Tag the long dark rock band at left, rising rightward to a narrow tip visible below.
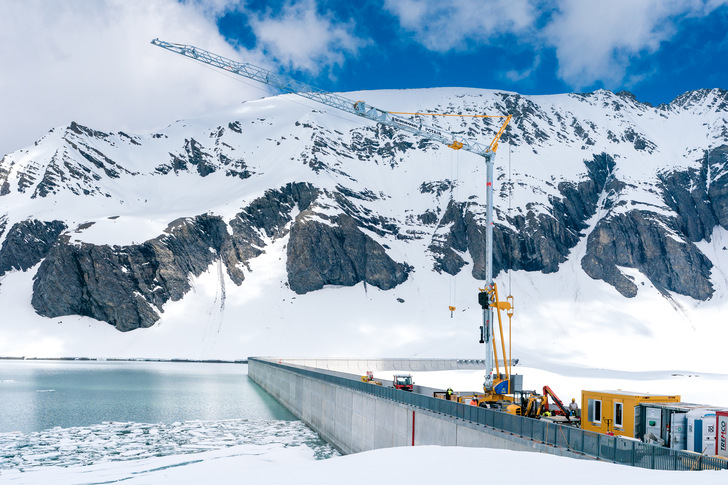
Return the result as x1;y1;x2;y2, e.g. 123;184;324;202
28;184;317;331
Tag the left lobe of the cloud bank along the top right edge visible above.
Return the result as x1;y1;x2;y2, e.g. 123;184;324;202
384;0;538;52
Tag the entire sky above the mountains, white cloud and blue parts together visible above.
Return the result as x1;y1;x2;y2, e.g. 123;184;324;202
0;0;728;156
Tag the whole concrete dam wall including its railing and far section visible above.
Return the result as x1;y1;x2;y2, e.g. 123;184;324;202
248;357;728;470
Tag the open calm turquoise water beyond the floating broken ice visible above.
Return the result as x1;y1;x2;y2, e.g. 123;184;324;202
0;360;296;433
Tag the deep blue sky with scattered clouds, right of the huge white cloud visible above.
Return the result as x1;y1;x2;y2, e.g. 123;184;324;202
217;0;728;105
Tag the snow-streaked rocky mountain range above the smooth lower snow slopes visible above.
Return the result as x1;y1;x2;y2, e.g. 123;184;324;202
0;86;728;331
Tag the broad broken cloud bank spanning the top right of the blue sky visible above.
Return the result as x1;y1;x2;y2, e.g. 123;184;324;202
384;0;728;89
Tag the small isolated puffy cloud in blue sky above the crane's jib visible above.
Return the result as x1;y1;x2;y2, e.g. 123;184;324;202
251;0;366;74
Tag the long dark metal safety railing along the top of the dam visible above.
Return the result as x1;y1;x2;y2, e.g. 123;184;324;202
248;357;728;470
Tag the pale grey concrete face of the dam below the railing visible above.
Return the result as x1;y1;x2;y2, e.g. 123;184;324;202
248;358;583;456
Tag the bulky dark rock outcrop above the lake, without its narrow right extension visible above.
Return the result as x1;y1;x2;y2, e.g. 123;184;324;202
31;215;227;331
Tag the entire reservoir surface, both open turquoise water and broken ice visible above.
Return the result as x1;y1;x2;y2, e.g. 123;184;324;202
0;360;336;471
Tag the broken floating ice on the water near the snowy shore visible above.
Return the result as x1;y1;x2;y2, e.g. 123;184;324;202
0;419;338;470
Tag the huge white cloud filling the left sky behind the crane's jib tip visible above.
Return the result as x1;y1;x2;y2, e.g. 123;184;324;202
0;0;263;157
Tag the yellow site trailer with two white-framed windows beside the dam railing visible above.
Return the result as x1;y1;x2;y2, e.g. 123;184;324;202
581;391;680;438
